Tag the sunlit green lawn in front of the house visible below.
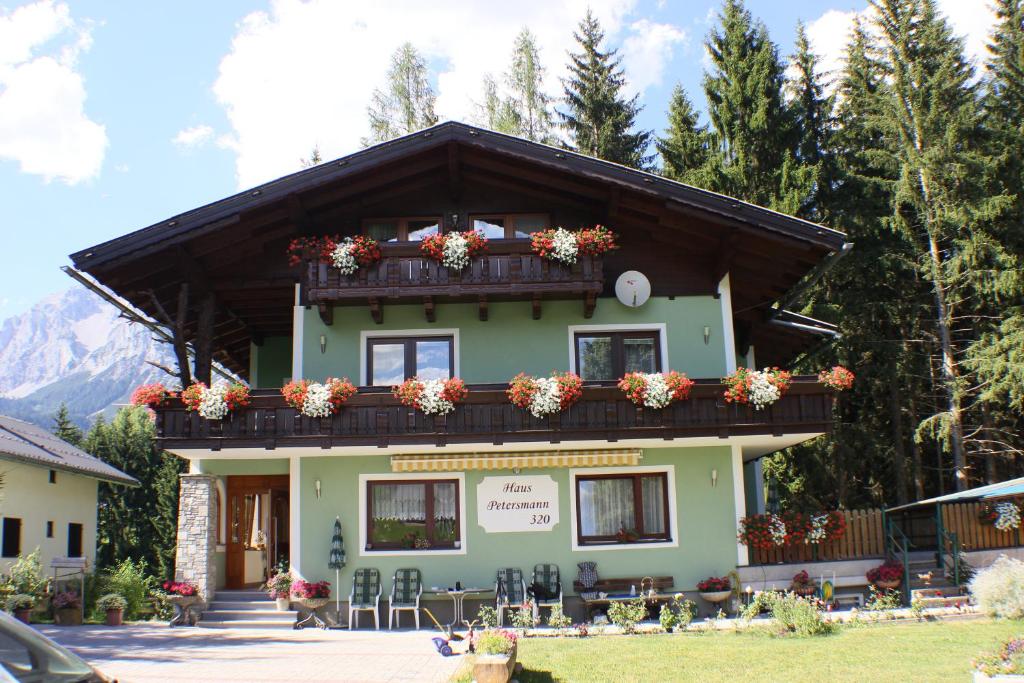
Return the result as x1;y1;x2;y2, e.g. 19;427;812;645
457;620;1024;683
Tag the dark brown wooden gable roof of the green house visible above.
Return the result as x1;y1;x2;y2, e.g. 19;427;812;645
71;122;845;374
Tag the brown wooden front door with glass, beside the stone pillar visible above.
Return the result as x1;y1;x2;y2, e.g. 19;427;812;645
224;474;289;589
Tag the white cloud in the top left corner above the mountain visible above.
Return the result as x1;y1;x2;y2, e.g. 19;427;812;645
0;0;108;185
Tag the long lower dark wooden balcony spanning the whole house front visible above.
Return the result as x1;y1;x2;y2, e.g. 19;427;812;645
157;377;833;451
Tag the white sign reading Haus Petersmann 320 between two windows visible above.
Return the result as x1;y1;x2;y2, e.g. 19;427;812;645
476;474;558;533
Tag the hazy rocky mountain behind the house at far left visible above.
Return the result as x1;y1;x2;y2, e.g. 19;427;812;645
0;287;172;428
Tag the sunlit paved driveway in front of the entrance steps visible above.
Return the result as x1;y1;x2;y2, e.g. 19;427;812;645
37;625;462;683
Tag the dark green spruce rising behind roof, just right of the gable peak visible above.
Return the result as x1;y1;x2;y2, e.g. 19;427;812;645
559;10;652;168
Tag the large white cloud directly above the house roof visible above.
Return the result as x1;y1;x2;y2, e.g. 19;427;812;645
213;0;667;186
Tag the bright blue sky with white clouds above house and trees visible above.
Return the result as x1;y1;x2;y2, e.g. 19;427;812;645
0;0;990;318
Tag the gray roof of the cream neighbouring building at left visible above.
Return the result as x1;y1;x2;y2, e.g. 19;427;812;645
0;415;138;486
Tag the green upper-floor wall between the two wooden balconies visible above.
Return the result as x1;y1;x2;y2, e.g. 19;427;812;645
299;296;725;384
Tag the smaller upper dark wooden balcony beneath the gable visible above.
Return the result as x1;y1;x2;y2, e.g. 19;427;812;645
304;240;604;325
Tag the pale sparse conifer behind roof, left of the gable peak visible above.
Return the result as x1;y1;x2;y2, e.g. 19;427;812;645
362;43;437;146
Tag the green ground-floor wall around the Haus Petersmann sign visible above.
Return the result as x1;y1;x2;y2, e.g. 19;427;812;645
299;447;736;599
